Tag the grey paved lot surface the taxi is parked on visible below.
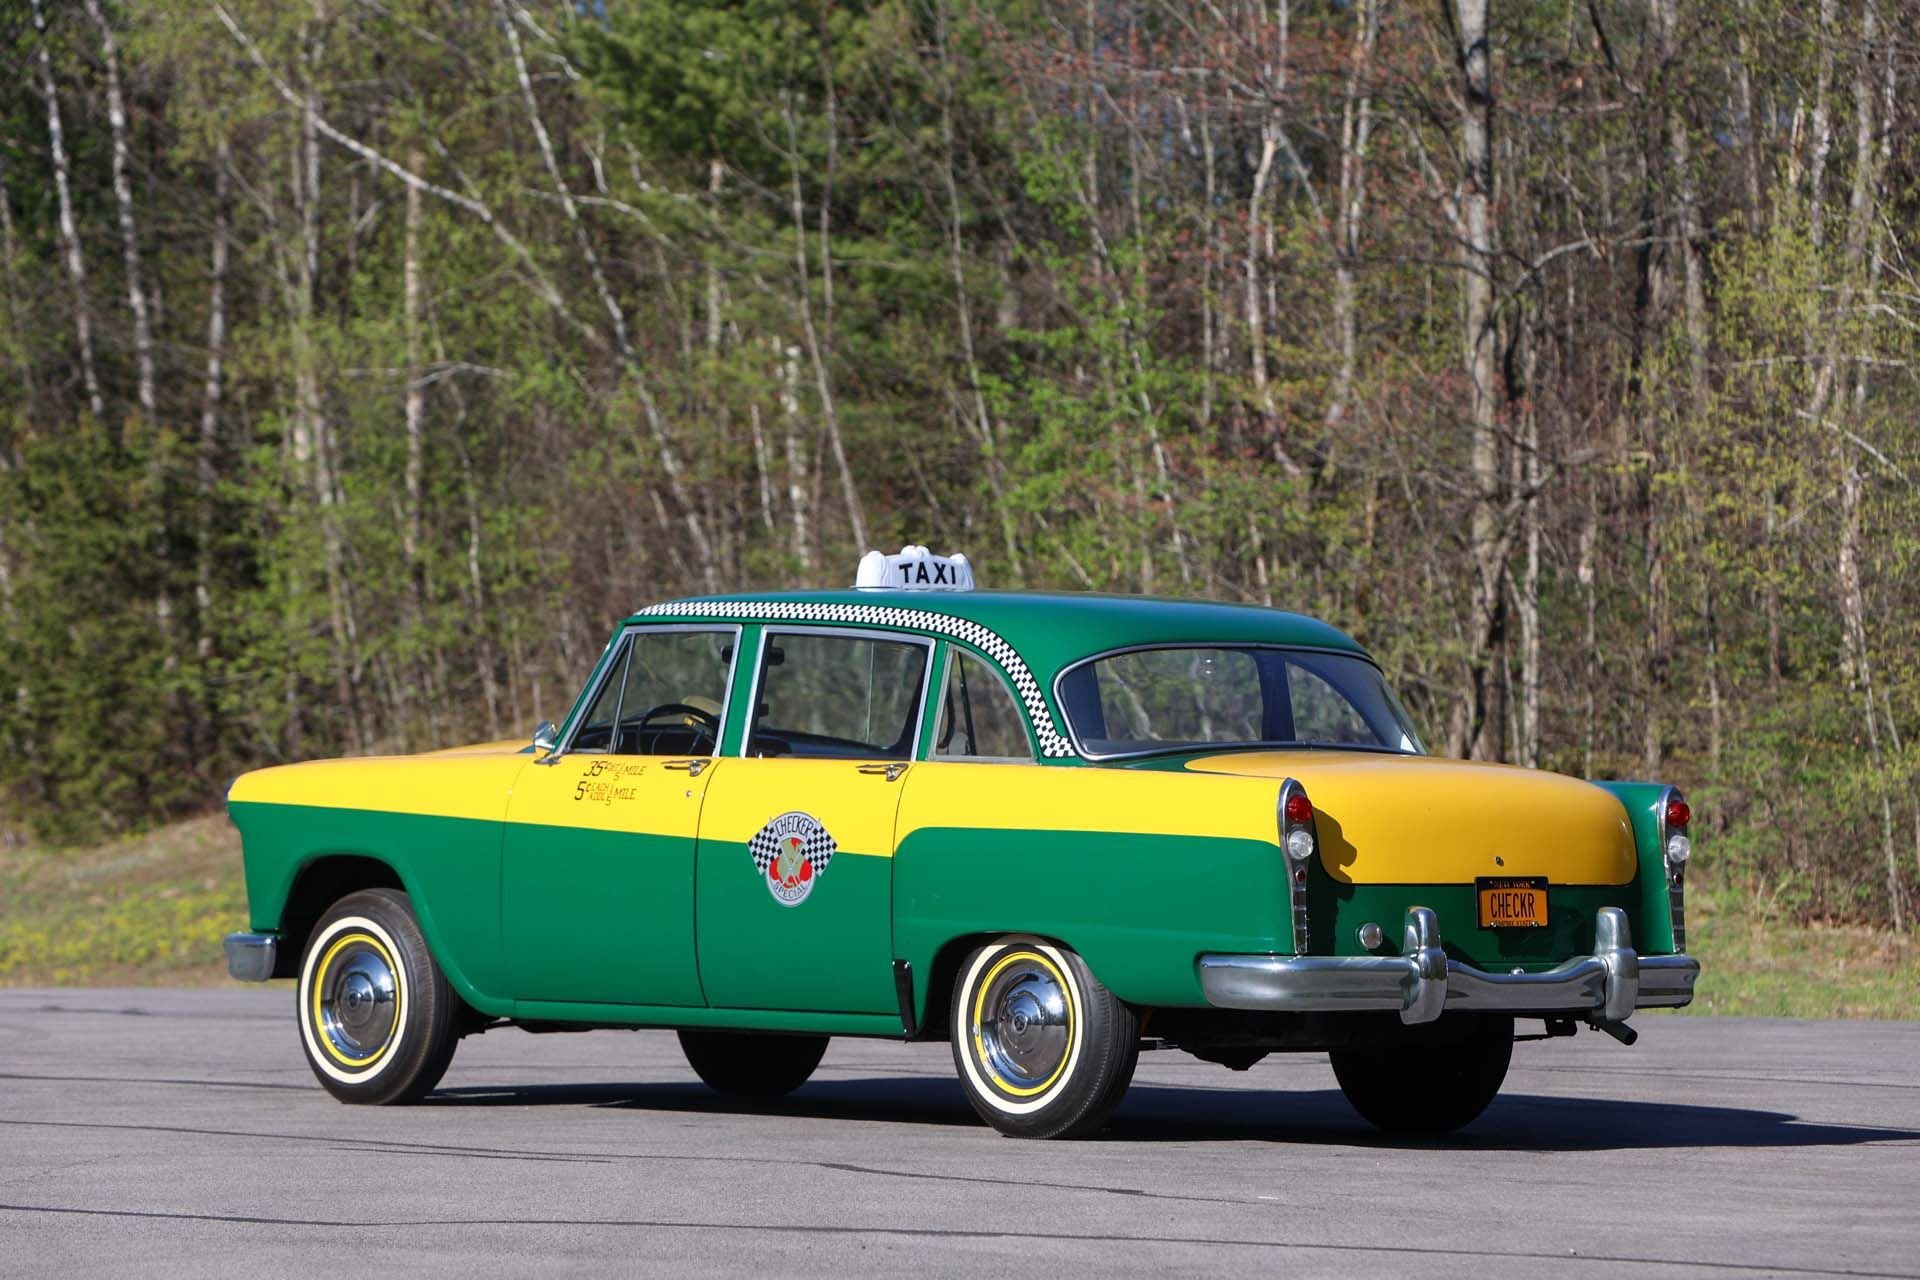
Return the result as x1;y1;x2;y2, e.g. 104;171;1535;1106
0;988;1920;1280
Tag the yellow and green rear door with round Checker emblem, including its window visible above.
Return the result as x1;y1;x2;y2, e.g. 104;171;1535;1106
695;628;931;1013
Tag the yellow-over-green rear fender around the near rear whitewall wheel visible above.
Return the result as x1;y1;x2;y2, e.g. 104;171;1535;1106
893;762;1292;1025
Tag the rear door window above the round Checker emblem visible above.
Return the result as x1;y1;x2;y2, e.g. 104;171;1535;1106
747;631;929;760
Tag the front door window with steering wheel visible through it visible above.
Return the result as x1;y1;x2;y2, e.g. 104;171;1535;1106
572;629;733;756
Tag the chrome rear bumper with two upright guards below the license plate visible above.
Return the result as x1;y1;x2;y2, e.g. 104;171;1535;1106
1200;906;1699;1023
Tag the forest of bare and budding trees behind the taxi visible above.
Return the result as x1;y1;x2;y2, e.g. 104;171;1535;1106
0;0;1920;929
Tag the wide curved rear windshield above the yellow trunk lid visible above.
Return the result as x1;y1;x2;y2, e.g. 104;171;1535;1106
1058;647;1427;756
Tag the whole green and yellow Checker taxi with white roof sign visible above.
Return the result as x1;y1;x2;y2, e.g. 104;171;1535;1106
227;547;1699;1136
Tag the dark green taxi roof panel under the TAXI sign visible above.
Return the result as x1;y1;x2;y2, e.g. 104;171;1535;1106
628;589;1367;676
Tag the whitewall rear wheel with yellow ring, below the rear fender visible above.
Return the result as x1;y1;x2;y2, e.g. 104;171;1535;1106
952;938;1140;1138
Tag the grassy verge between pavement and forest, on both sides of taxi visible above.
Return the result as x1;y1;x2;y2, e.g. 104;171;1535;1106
0;814;1920;1019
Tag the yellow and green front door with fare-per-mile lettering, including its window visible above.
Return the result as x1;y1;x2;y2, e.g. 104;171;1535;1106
501;626;737;1006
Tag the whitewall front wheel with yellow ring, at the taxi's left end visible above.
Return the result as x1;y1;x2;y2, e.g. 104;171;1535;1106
298;889;461;1103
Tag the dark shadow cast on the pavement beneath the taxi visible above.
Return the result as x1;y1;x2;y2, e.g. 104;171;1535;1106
426;1077;1920;1151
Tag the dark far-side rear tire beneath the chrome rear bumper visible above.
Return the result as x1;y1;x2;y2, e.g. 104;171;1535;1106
1331;1013;1513;1134
